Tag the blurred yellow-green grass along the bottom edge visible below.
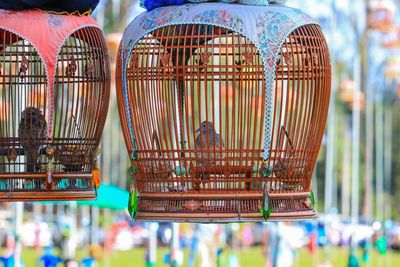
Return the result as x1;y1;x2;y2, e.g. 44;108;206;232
8;247;400;267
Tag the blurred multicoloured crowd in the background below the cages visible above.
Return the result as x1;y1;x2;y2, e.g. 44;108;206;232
0;210;400;267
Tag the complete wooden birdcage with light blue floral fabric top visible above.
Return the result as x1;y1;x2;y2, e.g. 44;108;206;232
116;3;331;222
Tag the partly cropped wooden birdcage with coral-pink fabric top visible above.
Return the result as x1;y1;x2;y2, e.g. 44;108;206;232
0;10;110;201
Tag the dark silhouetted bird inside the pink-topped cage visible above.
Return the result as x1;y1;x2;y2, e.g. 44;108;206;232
18;107;47;173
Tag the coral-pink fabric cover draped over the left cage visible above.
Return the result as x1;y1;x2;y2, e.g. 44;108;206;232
0;9;99;138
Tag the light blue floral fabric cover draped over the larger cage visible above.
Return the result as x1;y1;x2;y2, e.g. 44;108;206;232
121;3;316;159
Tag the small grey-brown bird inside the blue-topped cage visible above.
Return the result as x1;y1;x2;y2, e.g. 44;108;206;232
195;121;225;172
